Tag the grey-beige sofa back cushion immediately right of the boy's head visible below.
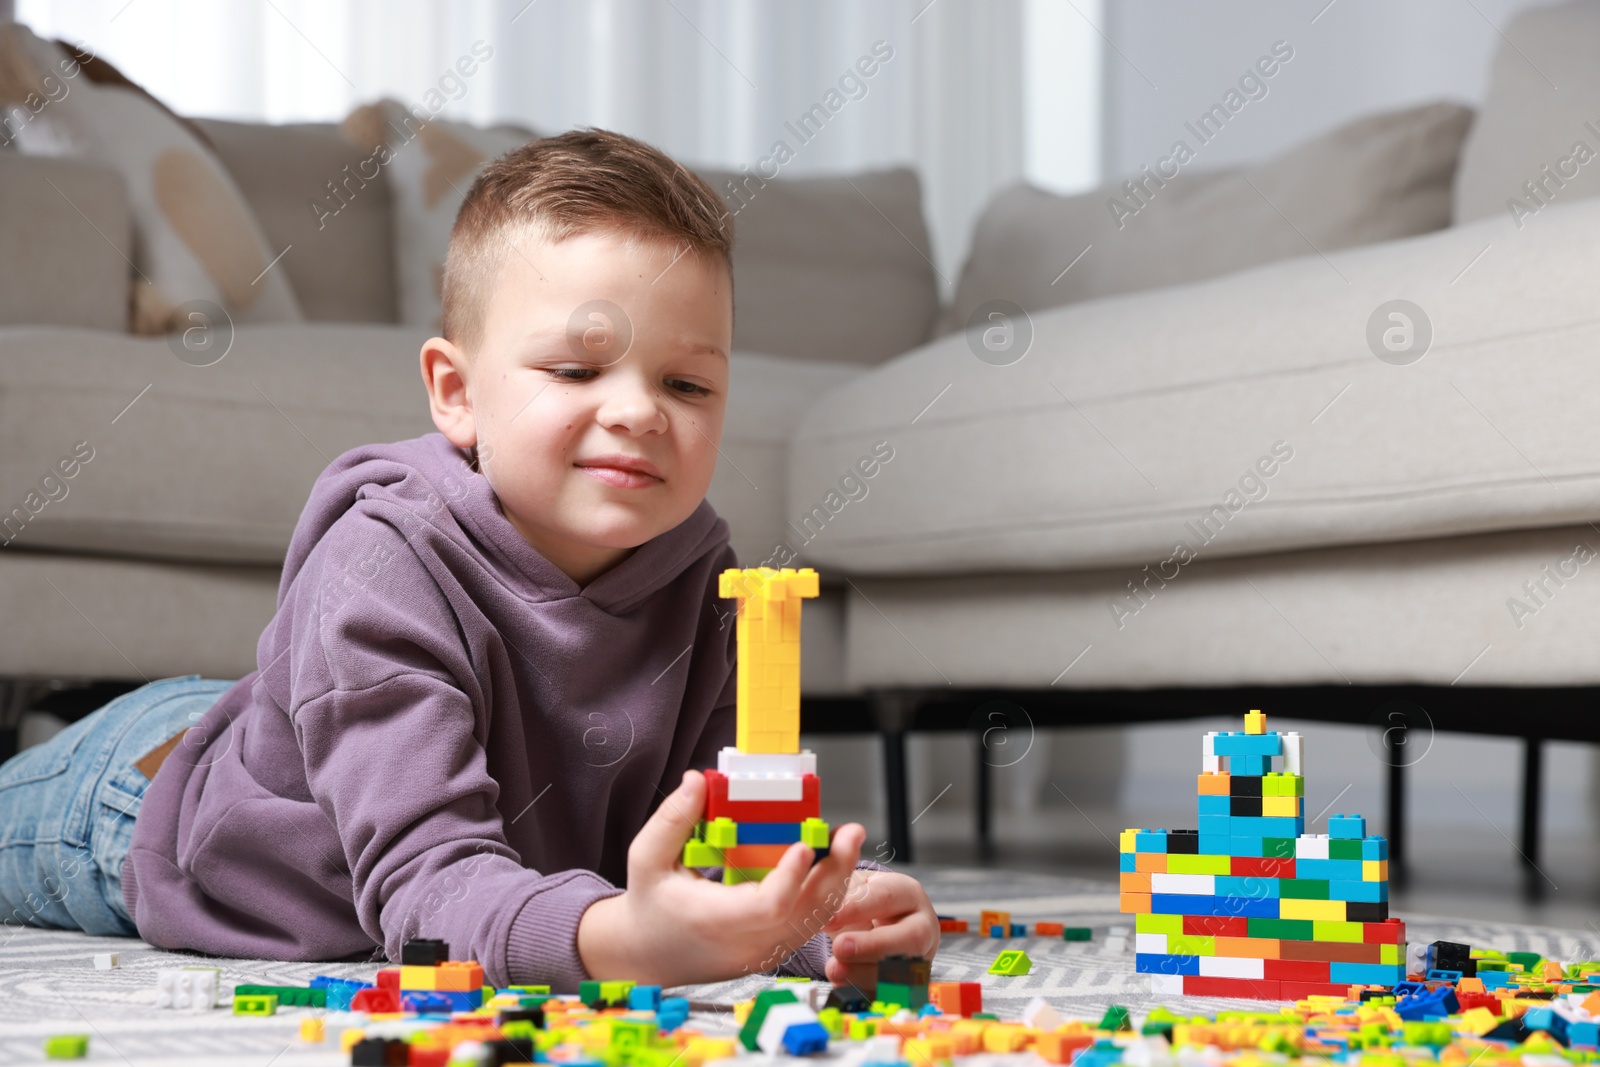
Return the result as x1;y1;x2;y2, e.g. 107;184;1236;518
696;166;939;363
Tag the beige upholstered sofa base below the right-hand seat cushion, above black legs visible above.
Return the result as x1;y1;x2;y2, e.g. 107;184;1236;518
844;521;1600;687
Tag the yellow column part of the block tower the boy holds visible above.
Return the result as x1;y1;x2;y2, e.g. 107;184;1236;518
718;566;818;753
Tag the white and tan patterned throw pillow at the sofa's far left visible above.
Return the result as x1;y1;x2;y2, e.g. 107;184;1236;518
0;22;301;333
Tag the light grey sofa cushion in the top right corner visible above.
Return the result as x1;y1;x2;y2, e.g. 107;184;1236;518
1454;0;1600;227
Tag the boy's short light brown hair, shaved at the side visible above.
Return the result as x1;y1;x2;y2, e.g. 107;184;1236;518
442;128;733;360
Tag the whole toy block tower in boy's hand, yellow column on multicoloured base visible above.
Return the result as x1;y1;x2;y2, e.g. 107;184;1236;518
683;566;829;885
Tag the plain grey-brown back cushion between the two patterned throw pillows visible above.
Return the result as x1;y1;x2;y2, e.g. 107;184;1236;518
194;118;397;323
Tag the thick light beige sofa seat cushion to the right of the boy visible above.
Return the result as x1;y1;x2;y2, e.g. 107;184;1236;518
789;191;1600;581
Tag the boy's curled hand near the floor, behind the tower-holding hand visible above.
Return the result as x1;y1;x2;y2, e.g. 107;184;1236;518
822;870;939;993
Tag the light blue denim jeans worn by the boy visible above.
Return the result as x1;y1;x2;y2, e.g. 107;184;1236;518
0;675;234;936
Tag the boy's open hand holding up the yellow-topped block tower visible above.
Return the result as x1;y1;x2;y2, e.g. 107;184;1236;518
578;771;870;985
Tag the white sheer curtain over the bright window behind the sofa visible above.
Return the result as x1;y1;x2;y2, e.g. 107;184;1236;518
14;0;1099;294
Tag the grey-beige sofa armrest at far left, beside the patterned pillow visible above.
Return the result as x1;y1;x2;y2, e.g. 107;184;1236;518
0;152;133;333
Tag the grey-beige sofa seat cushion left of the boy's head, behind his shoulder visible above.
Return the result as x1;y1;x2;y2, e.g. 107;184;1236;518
0;323;434;565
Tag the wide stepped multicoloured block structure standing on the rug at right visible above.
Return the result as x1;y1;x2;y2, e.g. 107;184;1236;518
1122;710;1406;1000
